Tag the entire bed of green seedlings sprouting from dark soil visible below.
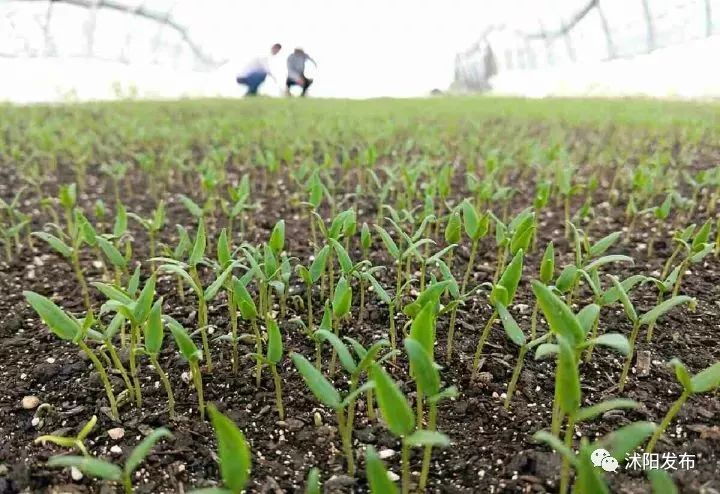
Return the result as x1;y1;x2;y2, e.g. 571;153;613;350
0;98;720;493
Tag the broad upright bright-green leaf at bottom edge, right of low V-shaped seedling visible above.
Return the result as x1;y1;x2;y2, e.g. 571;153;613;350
190;404;252;494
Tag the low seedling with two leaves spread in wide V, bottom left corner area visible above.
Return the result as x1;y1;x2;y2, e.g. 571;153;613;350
47;427;173;494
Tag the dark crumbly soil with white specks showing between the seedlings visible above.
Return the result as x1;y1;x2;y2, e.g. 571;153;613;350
0;113;720;493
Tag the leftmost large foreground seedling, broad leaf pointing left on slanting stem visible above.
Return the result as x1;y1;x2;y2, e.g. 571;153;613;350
23;291;119;420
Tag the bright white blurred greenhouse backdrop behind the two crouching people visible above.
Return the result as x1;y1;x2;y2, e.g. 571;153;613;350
0;0;720;102
